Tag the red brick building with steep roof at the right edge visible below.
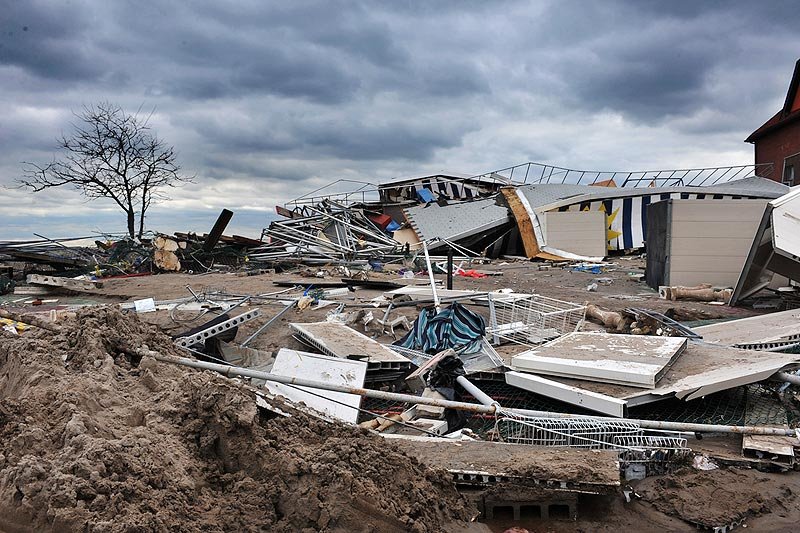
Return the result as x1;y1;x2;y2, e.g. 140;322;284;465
745;59;800;186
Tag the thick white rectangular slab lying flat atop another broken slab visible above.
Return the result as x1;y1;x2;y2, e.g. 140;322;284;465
512;332;686;388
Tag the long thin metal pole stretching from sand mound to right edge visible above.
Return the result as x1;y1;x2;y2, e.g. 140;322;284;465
147;348;795;436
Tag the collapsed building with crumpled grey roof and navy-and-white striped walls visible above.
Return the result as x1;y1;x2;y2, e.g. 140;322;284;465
253;163;789;260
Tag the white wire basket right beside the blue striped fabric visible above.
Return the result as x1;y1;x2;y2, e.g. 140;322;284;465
486;293;586;346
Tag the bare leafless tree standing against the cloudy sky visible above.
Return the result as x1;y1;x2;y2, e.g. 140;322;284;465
18;102;192;238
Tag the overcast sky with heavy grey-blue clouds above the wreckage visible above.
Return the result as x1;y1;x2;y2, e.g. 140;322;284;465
0;0;800;239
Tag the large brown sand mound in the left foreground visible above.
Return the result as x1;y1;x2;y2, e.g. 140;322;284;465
0;308;471;532
